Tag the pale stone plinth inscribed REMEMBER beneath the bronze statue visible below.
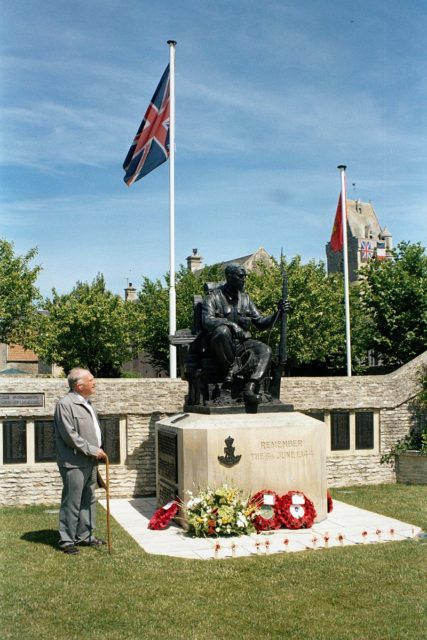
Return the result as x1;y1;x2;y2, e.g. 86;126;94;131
156;412;327;522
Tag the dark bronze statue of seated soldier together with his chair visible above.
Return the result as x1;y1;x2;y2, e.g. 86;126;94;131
172;264;289;406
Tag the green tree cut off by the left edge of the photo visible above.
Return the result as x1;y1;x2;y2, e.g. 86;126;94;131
0;240;41;347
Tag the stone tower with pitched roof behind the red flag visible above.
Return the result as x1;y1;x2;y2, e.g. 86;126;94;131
326;200;393;282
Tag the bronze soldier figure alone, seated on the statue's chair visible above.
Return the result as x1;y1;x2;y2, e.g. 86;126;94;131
202;264;284;404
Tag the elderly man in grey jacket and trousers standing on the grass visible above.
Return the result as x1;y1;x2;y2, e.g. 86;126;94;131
54;368;106;555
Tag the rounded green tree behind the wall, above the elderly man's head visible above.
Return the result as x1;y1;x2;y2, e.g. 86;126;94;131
37;275;143;378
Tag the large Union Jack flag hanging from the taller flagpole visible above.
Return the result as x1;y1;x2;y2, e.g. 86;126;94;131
123;65;170;187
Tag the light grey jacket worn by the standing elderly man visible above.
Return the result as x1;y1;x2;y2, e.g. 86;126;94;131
54;391;99;468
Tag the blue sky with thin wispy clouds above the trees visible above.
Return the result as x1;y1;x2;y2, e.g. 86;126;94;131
0;0;427;295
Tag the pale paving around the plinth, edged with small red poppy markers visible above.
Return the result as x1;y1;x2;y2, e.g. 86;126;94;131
100;498;421;560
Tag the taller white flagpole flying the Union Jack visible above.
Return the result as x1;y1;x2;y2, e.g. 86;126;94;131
168;40;176;378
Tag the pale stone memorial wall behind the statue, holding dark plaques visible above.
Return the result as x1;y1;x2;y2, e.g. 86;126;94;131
0;352;427;505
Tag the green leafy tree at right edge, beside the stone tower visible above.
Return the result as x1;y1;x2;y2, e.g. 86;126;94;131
359;242;427;367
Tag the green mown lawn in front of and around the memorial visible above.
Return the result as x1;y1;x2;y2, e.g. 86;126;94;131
0;485;427;640
